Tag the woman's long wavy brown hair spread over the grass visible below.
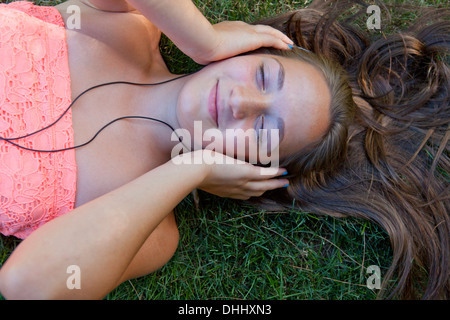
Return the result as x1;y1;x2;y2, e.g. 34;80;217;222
248;0;450;299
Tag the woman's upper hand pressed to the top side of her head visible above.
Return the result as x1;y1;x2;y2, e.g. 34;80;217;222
193;21;294;64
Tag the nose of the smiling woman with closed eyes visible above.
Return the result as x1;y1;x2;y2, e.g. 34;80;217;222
229;86;271;119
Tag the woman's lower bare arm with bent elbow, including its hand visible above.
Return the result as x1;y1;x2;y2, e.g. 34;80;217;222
0;151;288;299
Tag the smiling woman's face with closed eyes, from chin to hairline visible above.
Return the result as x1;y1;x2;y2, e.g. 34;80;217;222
177;54;330;163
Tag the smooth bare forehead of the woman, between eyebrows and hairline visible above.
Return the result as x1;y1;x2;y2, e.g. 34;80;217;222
275;57;331;157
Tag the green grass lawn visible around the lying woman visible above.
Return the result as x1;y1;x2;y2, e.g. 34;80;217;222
0;0;447;300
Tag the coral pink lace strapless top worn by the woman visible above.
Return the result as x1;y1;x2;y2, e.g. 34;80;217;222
0;1;77;239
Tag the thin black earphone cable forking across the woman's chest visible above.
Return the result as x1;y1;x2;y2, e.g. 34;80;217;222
0;73;192;153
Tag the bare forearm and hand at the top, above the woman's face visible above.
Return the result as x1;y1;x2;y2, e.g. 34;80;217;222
83;0;293;64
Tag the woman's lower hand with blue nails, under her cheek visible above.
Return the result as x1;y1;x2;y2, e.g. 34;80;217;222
176;150;289;200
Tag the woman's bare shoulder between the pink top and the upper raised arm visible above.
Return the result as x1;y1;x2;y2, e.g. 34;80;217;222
57;0;161;93
